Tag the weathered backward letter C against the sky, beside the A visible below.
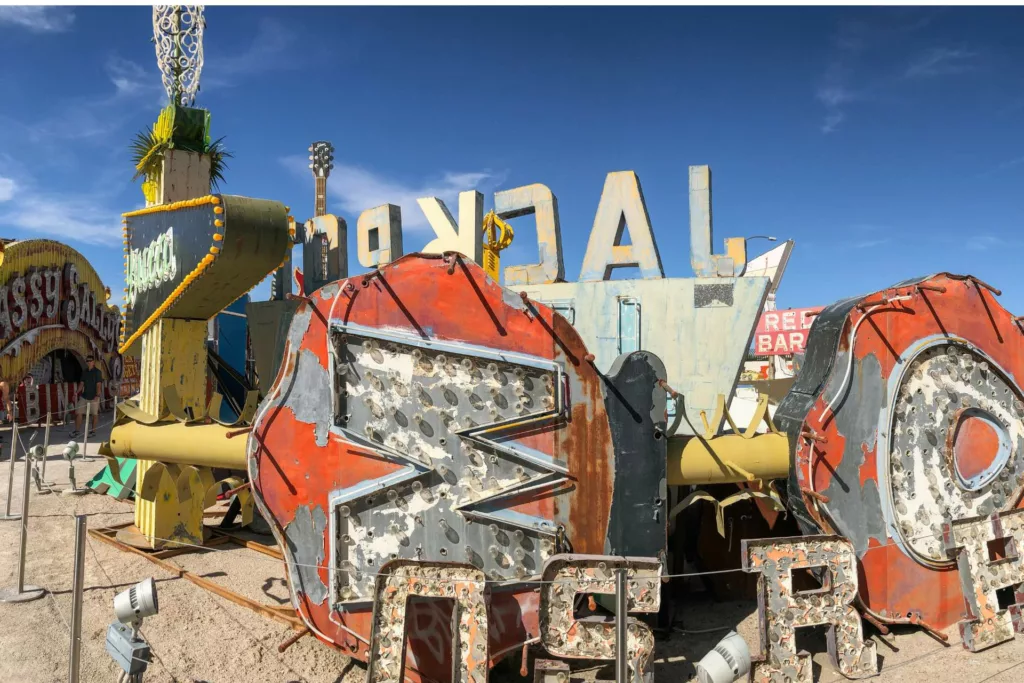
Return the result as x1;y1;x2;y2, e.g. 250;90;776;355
495;183;565;287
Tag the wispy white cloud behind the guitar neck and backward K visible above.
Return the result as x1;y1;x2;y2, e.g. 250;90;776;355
282;157;506;231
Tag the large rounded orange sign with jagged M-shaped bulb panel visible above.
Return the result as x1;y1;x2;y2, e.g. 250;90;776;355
248;255;651;681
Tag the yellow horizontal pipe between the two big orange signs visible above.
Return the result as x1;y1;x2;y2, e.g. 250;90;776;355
669;433;790;486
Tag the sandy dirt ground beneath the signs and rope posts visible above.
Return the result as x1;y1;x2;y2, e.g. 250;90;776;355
0;412;1024;683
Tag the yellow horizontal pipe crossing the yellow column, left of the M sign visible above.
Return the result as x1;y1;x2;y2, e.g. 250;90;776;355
110;422;247;470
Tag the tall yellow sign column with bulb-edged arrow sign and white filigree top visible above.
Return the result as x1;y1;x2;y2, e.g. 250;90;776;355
117;6;289;548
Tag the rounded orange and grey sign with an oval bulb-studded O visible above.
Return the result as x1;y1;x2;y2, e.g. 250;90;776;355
775;273;1024;629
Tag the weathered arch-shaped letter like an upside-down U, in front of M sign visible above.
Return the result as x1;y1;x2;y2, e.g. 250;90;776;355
367;559;489;683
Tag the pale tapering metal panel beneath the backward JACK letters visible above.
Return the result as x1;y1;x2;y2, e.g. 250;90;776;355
510;278;769;435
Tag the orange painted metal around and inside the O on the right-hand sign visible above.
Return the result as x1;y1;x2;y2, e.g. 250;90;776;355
791;273;1024;629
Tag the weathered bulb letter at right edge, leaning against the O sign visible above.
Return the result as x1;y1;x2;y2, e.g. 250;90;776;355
942;510;1024;652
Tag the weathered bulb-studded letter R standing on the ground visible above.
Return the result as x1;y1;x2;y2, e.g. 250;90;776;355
740;536;879;683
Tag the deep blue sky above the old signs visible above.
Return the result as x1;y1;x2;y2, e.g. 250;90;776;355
0;7;1024;313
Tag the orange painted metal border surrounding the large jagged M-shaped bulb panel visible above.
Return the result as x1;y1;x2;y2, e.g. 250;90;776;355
249;254;613;681
